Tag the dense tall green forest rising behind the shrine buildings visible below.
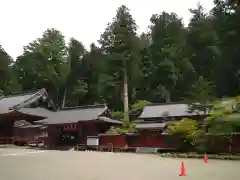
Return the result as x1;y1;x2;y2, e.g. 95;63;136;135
0;0;240;118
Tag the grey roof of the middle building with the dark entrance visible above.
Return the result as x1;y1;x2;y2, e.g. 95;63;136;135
37;105;107;124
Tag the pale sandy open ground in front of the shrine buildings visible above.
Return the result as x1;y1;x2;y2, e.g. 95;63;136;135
0;148;240;180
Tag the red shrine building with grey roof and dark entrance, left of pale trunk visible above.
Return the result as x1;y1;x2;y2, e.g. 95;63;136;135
34;105;121;146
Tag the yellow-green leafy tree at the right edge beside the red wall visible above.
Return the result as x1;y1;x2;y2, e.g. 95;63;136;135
204;97;240;152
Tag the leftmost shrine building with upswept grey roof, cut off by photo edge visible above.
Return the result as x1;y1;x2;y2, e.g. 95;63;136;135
0;89;54;143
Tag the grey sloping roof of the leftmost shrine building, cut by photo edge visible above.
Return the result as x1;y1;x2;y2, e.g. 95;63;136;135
0;89;46;114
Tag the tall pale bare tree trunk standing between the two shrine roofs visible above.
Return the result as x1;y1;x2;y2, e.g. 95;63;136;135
123;68;129;121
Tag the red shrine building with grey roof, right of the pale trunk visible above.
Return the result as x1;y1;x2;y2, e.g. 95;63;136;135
132;103;208;149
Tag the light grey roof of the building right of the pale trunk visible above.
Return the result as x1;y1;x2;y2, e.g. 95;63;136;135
138;103;204;119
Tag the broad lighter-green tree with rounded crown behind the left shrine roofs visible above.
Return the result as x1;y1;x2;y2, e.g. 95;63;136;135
18;29;71;105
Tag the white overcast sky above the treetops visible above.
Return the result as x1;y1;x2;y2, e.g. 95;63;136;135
0;0;213;59
